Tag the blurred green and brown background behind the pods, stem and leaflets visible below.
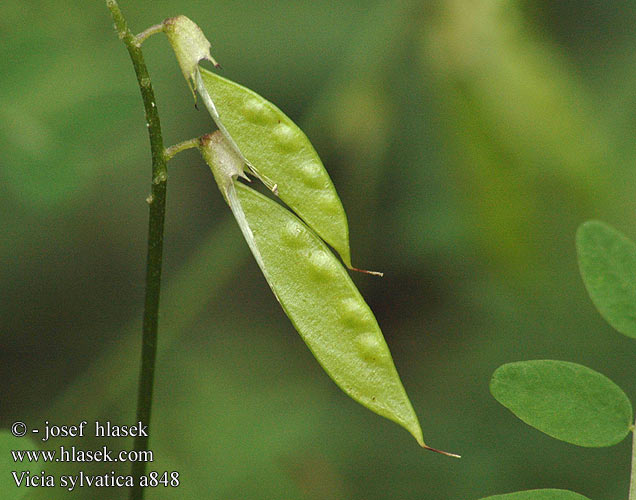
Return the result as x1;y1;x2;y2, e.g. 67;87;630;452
0;0;636;500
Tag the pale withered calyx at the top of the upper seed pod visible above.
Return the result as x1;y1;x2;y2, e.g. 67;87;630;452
162;16;219;101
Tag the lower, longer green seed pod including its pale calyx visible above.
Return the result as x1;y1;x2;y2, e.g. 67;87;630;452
201;132;437;451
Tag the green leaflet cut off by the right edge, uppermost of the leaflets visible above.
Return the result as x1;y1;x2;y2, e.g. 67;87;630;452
576;221;636;338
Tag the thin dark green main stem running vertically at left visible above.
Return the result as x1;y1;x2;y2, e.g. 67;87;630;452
106;0;168;500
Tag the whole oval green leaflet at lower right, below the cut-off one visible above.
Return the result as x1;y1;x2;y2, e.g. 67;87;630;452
490;360;633;447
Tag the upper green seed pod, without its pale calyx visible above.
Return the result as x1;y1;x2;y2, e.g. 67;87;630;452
197;68;351;268
